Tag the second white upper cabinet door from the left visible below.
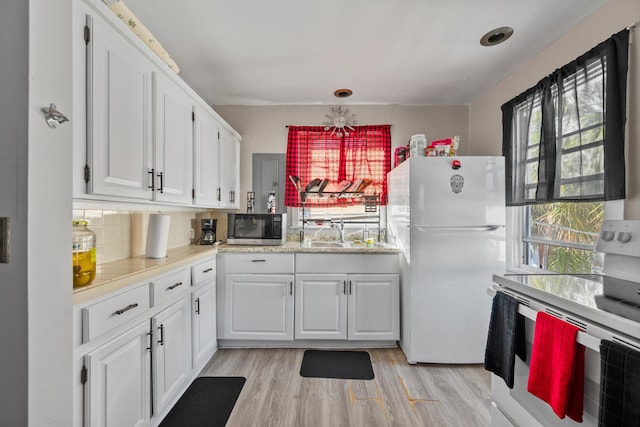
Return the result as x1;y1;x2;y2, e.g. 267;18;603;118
153;73;193;204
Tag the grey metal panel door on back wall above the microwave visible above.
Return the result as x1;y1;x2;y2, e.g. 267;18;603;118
252;153;286;213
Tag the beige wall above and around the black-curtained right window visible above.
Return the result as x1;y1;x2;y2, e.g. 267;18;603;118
469;0;640;219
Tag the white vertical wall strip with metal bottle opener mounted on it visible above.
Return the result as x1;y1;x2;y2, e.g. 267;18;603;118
23;0;74;427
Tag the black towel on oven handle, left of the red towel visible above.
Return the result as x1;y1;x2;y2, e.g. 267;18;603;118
484;292;527;388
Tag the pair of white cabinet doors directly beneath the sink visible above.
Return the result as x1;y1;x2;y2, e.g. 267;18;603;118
295;274;400;341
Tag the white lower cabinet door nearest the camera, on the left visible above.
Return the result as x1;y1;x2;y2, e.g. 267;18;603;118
85;320;151;427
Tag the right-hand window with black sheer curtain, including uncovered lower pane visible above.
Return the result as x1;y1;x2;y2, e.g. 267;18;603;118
502;30;629;273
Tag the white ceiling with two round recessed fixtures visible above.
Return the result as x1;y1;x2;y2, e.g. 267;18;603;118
124;0;606;105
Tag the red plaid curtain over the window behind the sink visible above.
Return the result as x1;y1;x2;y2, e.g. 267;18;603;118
285;125;391;207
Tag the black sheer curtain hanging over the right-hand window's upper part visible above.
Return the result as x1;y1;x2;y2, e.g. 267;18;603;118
502;30;629;206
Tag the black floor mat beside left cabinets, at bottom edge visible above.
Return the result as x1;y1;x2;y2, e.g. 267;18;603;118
160;377;246;427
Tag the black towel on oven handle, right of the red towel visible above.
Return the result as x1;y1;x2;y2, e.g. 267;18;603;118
598;340;640;427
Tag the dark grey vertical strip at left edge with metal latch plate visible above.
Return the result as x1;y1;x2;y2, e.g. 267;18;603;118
0;1;29;426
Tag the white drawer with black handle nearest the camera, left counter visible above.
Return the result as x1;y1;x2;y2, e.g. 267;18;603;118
82;283;149;343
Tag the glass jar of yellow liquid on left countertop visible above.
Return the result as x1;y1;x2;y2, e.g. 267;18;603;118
73;221;96;288
